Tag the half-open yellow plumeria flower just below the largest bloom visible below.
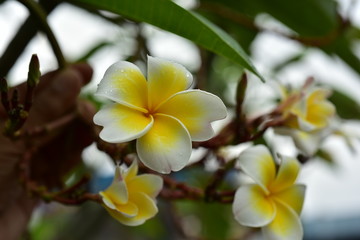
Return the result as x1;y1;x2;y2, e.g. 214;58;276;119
100;161;163;226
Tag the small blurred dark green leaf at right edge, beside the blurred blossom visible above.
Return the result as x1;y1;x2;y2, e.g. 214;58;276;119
329;90;360;119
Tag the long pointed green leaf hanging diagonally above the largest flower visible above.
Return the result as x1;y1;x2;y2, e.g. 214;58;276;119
74;0;263;80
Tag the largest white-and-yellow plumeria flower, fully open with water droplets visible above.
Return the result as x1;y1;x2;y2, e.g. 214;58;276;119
94;56;226;173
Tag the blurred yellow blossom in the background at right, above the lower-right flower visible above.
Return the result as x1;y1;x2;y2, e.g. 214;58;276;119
283;86;335;132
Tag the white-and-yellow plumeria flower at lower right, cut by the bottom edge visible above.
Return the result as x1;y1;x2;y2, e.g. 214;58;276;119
233;145;305;240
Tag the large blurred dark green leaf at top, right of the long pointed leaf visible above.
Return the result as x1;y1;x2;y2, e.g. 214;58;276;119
202;0;338;37
